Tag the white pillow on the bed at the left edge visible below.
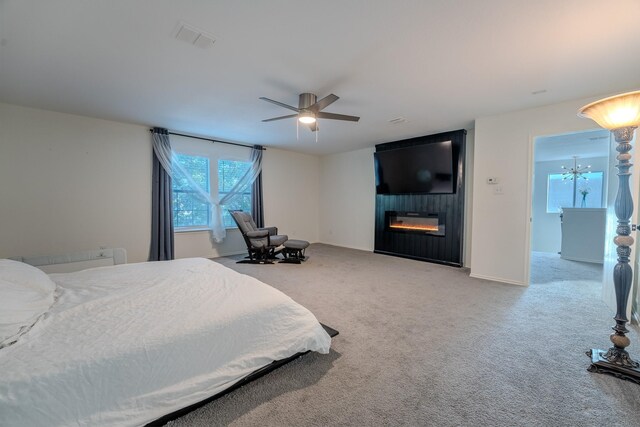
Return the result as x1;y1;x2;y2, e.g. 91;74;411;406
0;259;56;348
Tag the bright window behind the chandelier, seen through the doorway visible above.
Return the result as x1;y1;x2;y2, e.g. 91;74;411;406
547;172;604;213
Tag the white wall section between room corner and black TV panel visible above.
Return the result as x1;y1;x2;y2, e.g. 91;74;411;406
320;148;376;251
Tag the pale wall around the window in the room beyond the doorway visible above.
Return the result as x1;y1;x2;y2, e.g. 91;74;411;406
531;153;609;253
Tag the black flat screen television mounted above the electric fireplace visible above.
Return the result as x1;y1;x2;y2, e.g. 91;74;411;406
374;141;455;194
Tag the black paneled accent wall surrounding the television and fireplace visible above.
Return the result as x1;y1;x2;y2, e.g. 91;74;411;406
374;129;467;267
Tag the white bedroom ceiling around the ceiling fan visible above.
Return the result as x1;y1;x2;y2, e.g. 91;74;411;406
0;0;640;154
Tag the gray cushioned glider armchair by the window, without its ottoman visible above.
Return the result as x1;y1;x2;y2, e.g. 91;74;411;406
229;210;288;264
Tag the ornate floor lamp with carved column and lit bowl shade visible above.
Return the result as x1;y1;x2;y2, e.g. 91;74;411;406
578;91;640;384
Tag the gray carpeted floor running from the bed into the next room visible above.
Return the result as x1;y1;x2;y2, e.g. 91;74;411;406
170;244;640;427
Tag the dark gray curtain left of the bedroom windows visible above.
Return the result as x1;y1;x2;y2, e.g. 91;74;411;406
149;128;174;261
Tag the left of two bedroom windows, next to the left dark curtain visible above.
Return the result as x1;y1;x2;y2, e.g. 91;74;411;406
172;154;210;228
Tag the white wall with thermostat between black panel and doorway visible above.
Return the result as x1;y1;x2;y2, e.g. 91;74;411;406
471;97;624;285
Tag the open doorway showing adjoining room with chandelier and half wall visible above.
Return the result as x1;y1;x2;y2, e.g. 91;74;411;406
529;130;611;289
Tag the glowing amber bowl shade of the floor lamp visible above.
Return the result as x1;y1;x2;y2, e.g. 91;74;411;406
578;90;640;130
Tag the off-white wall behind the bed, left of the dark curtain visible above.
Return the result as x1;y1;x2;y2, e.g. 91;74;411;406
0;104;151;261
